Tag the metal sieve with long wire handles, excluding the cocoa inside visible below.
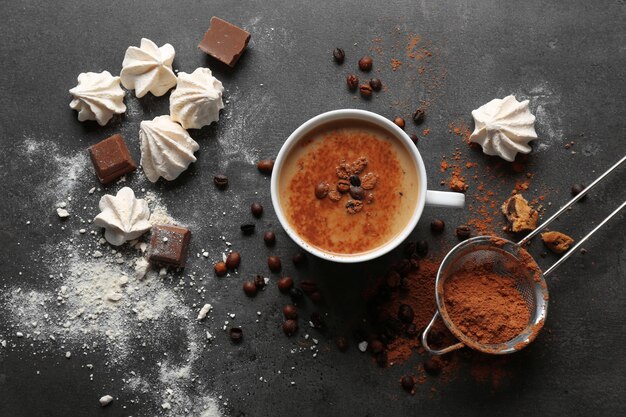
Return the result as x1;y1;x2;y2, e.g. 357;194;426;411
422;156;626;355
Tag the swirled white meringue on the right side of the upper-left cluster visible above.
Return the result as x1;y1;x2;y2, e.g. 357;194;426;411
170;68;224;129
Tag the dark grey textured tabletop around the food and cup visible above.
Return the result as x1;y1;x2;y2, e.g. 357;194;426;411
0;0;626;417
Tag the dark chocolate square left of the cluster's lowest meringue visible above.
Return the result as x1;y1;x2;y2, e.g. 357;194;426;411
89;135;137;184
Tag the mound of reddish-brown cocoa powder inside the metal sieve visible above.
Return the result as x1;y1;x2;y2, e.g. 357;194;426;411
444;261;530;344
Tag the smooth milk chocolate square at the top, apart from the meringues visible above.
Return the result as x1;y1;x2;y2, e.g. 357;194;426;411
198;16;250;67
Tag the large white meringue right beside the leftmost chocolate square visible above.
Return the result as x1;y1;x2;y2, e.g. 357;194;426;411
139;116;200;182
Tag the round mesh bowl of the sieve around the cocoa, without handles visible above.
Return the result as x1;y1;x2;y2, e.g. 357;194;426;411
436;236;548;353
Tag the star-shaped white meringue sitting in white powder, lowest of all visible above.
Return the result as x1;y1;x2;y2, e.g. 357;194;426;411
94;187;152;246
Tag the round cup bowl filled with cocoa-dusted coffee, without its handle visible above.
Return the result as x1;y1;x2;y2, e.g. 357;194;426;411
271;110;428;263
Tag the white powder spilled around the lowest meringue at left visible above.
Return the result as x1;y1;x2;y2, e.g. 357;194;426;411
0;138;221;417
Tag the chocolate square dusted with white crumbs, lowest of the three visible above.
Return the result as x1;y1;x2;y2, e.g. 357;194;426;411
149;225;191;268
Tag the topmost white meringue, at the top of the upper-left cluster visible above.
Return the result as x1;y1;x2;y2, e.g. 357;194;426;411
120;38;176;97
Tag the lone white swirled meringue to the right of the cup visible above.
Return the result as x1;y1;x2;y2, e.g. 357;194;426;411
470;96;537;162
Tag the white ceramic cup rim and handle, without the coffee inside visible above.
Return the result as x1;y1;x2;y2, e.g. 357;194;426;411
271;109;465;263
